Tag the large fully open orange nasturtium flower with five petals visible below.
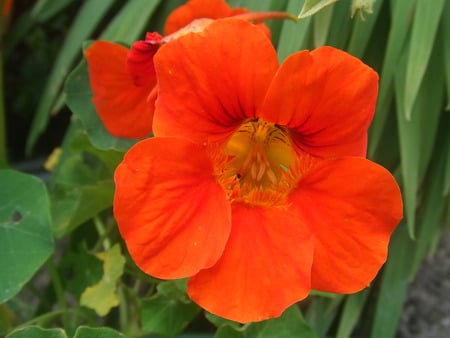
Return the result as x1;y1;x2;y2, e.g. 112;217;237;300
114;19;402;323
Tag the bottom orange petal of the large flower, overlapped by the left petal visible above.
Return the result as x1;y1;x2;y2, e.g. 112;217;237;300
188;204;313;323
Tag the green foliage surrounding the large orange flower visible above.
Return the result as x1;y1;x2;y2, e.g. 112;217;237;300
0;0;450;338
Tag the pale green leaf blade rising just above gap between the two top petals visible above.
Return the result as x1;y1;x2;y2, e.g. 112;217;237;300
277;0;311;62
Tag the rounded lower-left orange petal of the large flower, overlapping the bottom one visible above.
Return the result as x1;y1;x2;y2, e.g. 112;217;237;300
114;138;231;279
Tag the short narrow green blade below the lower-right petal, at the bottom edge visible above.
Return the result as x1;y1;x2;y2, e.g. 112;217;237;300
336;289;369;338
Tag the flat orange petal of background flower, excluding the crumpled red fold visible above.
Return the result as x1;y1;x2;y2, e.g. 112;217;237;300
84;41;156;138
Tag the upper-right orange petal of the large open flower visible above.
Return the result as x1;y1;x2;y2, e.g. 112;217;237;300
261;47;378;157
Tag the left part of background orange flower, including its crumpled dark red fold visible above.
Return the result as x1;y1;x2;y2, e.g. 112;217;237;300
84;33;162;138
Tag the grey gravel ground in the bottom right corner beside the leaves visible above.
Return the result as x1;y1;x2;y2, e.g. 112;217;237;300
397;233;450;338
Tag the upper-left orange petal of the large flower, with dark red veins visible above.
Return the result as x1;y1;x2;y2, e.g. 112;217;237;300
153;19;278;141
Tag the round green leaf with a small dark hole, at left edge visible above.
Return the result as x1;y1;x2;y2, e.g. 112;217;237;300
0;170;54;303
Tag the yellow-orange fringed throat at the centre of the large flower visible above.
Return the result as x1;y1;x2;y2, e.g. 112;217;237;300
214;119;300;206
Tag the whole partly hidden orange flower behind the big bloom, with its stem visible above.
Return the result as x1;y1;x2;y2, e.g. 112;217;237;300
84;0;284;138
